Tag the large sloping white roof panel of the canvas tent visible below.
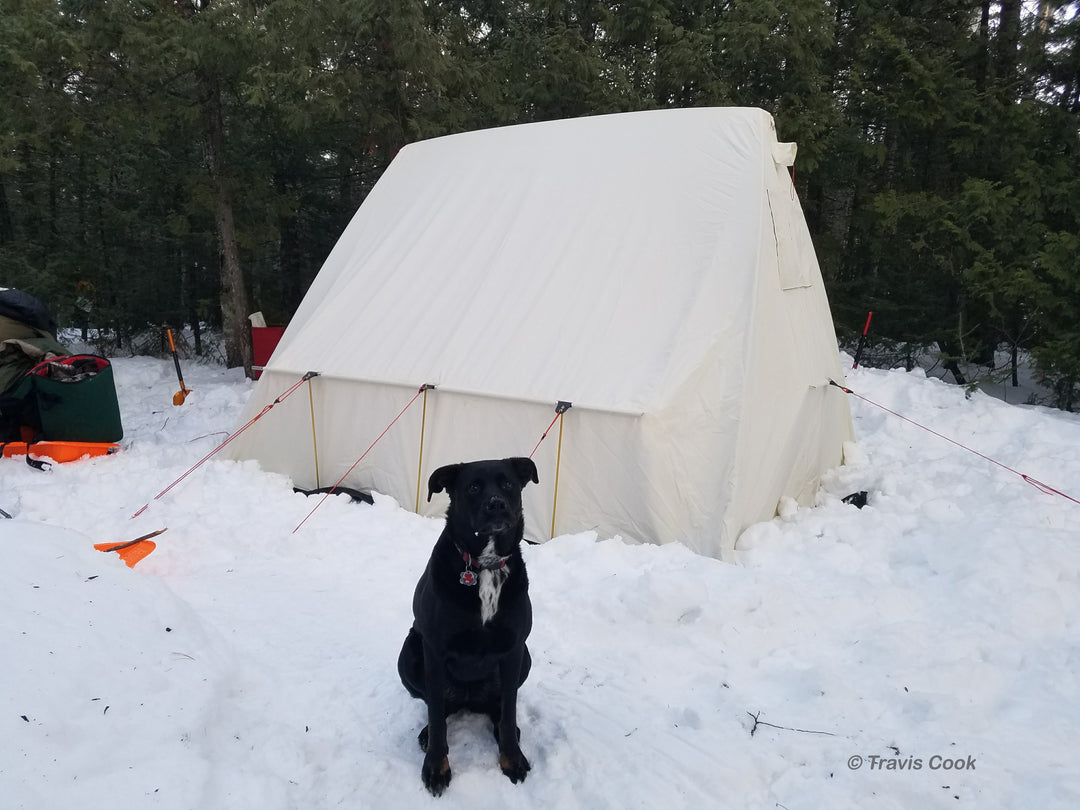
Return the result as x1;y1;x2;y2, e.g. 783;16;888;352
270;108;775;413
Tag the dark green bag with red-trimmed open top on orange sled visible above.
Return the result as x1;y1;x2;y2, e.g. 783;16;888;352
11;354;124;442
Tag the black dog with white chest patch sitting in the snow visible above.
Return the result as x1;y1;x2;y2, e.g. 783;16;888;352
397;458;539;796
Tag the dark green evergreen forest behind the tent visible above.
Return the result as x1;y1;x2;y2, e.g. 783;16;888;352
6;0;1080;409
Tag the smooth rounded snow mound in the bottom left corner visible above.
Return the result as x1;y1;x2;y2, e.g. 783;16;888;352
0;522;237;808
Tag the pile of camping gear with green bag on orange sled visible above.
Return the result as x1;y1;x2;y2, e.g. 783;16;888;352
0;289;123;464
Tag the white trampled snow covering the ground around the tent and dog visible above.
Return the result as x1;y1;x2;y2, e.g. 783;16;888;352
0;357;1080;810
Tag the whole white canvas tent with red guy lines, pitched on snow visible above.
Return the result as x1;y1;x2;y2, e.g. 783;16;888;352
231;108;852;557
